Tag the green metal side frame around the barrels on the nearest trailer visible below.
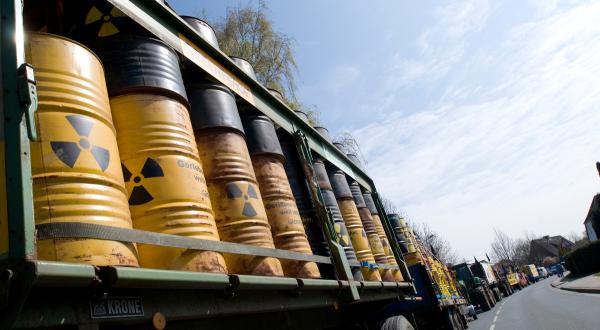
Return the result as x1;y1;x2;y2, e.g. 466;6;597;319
0;0;413;328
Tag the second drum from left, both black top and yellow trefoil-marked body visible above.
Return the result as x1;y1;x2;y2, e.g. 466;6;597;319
98;36;227;273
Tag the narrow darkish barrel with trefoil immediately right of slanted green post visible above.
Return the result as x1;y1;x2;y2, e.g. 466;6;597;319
313;158;368;281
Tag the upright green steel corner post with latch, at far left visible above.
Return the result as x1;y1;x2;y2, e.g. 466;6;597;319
0;0;35;260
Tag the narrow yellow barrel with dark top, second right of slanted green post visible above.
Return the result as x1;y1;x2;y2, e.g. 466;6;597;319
327;169;381;281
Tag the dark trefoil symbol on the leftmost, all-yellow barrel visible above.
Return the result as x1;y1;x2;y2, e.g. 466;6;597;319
50;115;110;172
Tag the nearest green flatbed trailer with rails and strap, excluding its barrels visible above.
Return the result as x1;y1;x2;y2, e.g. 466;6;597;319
0;0;454;330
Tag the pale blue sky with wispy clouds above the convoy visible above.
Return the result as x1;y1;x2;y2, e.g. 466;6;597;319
169;0;600;259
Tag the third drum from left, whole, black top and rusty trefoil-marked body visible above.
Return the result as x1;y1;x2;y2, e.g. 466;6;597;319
187;83;283;276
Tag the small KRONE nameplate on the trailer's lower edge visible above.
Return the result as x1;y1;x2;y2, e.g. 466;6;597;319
90;297;144;319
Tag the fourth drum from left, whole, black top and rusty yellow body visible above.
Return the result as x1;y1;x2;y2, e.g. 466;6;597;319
242;114;321;278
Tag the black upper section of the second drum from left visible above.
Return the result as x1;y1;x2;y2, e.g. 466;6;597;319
92;34;189;107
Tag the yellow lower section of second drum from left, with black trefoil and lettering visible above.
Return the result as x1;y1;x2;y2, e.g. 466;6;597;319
110;93;227;273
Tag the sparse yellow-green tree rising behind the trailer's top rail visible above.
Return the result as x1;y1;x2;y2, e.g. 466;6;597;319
213;1;302;104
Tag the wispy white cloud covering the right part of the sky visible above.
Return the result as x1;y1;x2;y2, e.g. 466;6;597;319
355;2;600;258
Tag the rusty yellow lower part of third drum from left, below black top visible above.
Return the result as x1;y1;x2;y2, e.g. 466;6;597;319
196;129;283;276
